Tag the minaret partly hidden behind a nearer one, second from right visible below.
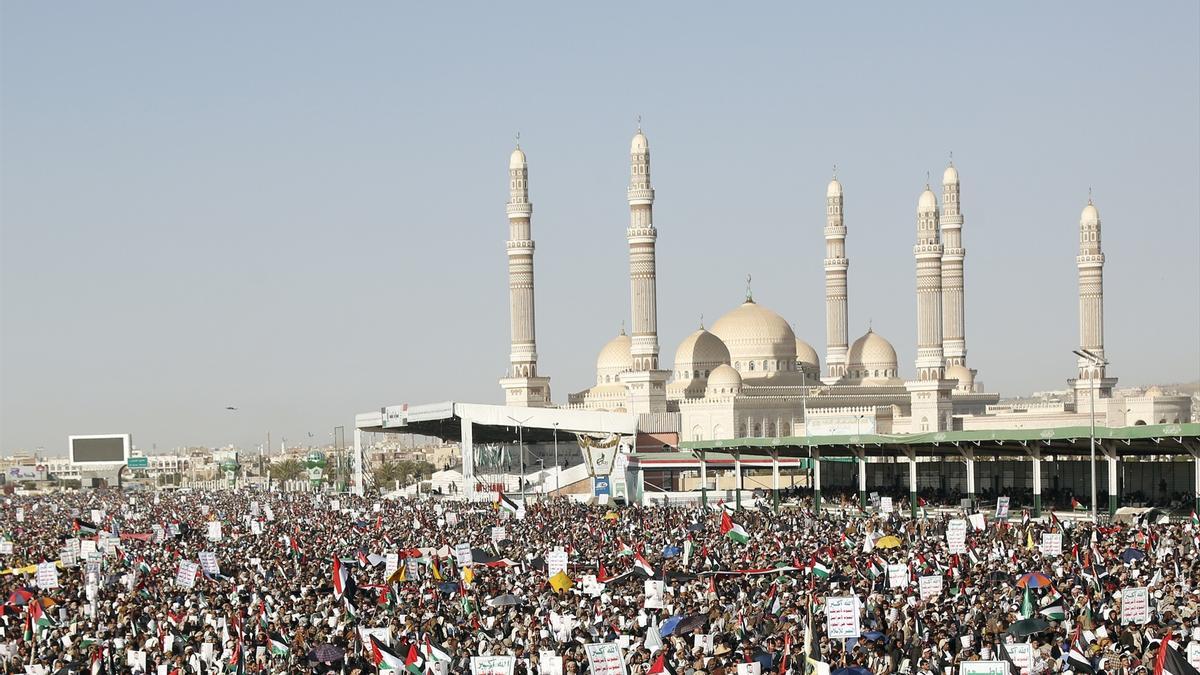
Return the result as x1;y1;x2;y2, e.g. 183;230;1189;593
941;160;974;389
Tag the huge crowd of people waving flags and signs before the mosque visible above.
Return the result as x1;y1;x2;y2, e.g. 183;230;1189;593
0;482;1200;675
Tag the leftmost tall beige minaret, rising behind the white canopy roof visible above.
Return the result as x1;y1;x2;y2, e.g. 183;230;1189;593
500;144;550;407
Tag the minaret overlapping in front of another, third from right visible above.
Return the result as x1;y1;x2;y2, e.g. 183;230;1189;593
906;184;954;434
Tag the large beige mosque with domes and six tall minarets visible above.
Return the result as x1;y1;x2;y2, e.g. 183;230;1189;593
500;129;1192;441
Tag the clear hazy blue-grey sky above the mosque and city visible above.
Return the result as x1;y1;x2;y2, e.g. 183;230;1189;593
0;0;1200;454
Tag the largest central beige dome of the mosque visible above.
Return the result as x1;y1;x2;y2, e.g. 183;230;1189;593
713;300;796;377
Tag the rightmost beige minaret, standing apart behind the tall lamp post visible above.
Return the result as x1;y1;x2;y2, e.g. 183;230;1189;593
1075;196;1117;412
